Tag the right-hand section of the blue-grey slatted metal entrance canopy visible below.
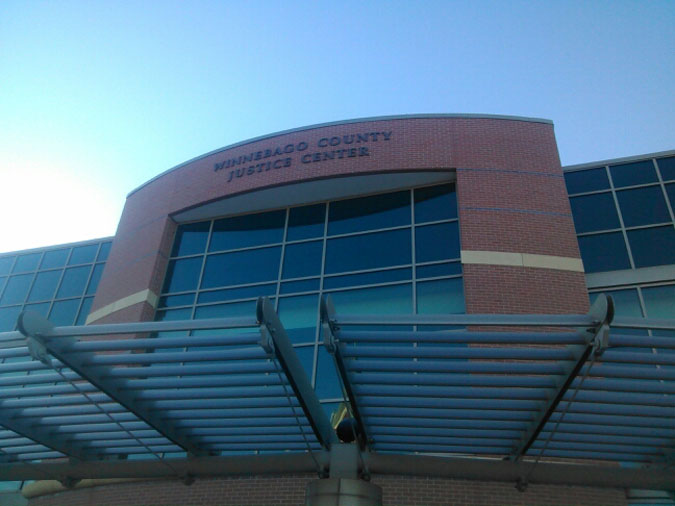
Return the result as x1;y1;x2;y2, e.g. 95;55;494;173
322;296;675;472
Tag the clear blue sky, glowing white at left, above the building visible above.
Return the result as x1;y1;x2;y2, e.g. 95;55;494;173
0;0;675;252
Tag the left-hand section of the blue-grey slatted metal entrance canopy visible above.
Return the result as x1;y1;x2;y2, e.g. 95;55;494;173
0;299;335;479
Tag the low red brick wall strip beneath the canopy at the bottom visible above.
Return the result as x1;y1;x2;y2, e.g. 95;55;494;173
28;475;627;506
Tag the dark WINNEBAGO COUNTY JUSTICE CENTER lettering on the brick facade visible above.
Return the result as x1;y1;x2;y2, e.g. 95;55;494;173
213;132;391;183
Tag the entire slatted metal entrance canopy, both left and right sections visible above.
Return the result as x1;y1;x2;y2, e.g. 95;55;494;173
0;296;675;490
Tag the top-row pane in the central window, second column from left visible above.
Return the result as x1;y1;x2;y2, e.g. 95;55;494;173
209;210;286;251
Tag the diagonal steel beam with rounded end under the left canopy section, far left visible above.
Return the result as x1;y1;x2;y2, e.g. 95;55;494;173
19;311;207;455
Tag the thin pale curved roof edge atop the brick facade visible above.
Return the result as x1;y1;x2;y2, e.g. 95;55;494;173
127;114;553;198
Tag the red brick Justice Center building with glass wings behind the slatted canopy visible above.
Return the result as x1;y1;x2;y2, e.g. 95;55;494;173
0;115;675;505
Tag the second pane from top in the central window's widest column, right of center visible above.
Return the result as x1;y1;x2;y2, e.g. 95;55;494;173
325;229;411;274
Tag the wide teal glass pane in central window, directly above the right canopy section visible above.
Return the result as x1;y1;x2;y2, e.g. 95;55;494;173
330;283;413;314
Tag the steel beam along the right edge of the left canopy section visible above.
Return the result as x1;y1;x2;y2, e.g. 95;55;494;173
257;297;337;449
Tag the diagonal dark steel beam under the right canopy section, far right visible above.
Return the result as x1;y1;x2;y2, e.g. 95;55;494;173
511;295;614;460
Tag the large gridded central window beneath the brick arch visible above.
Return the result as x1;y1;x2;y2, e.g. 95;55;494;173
157;184;464;403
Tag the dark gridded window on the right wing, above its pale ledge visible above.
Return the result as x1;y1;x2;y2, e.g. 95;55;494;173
565;156;675;272
